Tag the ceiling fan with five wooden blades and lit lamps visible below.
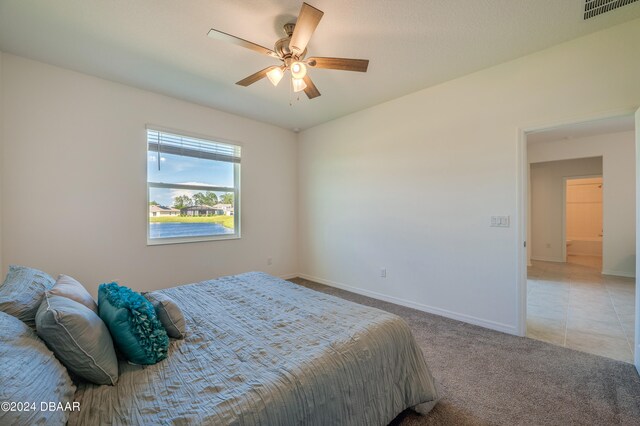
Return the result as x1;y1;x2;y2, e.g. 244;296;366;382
208;3;369;99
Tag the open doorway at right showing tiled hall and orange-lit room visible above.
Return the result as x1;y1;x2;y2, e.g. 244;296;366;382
519;115;637;362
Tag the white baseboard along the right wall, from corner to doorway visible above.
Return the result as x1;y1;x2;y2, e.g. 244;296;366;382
298;274;518;336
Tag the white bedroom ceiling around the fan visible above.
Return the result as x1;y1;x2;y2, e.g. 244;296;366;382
0;0;640;129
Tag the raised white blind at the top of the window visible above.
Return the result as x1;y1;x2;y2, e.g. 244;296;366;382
147;129;240;163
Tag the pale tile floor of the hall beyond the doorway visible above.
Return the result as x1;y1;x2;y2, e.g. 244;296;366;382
527;256;635;362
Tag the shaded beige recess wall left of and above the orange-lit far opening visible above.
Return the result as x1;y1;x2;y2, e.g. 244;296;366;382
527;157;602;262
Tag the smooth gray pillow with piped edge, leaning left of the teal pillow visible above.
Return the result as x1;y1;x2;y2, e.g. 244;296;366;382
36;292;118;385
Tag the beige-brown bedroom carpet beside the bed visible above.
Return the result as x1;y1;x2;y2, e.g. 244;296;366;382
291;279;640;426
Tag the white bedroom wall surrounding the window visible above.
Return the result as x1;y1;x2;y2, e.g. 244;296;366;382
0;54;297;294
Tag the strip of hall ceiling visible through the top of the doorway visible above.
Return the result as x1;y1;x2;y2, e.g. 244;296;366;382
527;115;635;143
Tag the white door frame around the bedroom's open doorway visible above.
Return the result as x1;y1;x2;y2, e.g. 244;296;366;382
515;107;640;342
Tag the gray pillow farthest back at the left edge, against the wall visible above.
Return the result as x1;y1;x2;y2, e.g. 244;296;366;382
0;265;55;330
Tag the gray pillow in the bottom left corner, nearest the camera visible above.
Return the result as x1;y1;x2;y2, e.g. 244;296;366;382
0;312;79;425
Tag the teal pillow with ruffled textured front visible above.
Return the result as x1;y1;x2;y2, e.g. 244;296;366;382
98;283;169;365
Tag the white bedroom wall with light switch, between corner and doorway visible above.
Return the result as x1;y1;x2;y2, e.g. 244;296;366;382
299;20;640;333
